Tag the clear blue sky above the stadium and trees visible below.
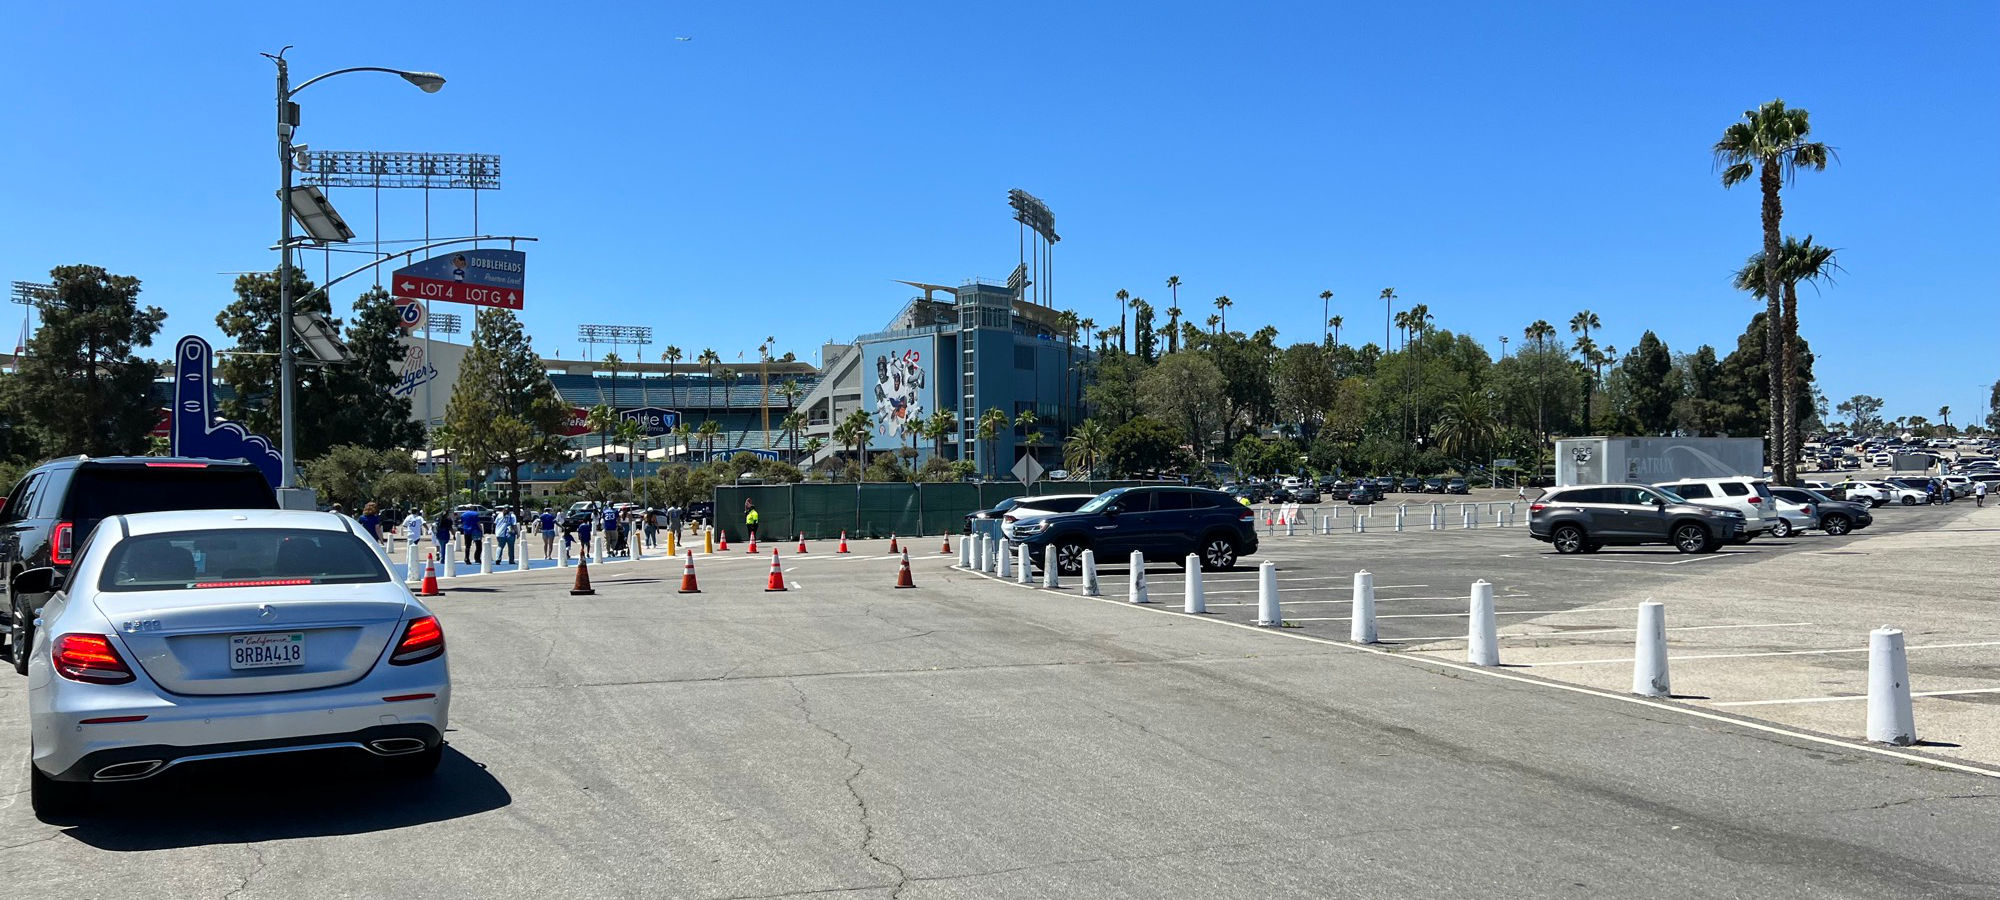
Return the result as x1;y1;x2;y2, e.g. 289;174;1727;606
0;2;2000;422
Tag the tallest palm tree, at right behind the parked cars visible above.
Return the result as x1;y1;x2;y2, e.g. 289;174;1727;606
1712;100;1834;486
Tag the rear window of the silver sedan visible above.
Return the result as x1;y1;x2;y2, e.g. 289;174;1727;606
98;528;388;590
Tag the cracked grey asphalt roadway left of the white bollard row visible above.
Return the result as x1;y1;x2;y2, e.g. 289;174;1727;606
0;546;2000;900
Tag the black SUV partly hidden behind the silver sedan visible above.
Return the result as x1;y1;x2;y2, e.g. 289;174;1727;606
0;456;278;674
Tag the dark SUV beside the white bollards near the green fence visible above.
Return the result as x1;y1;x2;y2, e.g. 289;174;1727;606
1008;488;1256;576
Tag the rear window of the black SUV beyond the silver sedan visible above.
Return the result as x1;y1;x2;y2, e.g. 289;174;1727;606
62;464;278;522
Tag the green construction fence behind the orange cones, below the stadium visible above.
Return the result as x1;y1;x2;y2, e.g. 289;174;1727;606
716;482;1146;540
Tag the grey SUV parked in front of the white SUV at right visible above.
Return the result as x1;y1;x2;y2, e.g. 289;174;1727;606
1528;484;1744;554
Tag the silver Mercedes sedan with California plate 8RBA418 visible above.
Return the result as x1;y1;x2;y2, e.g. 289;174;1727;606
14;510;452;818
